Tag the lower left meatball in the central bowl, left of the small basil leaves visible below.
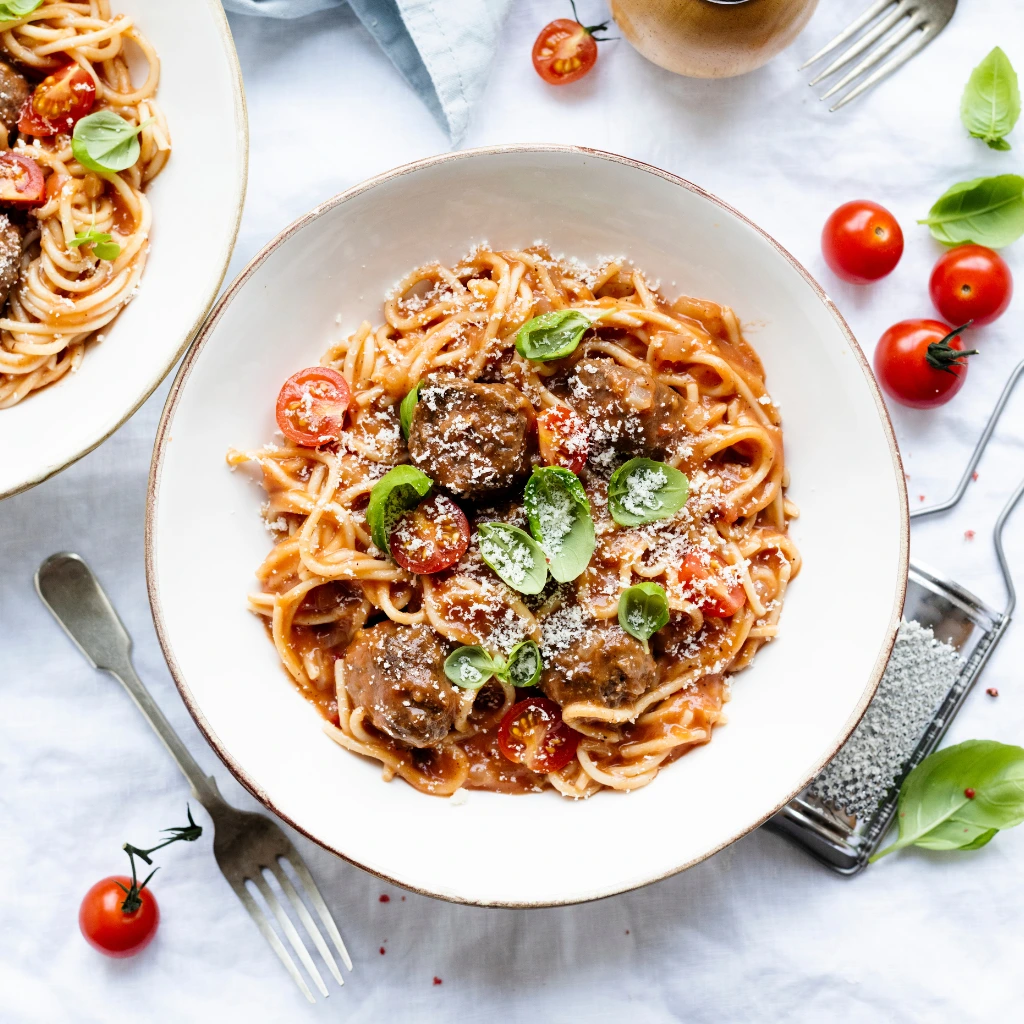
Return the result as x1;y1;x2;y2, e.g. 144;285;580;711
344;621;460;746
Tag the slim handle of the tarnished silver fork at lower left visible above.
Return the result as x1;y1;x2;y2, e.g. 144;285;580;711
36;552;222;809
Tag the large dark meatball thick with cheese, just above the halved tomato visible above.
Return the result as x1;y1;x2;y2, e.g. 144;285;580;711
409;380;534;498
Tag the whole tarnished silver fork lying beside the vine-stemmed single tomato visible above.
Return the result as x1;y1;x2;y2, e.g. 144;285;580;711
36;553;352;1002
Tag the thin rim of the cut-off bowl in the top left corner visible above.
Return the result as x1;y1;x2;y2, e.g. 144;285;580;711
0;0;249;501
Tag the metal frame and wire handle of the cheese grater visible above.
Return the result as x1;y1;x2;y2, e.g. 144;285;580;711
766;362;1024;874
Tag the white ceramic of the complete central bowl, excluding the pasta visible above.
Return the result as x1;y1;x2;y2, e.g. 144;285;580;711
147;146;908;905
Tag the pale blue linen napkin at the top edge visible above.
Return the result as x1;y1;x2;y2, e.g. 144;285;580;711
223;0;512;144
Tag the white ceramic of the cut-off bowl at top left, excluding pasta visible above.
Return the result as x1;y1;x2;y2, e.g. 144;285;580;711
0;0;249;498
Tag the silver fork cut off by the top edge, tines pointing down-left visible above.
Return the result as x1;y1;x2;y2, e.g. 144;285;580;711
800;0;956;111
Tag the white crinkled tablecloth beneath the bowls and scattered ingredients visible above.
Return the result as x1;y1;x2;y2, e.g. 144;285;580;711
0;0;1024;1024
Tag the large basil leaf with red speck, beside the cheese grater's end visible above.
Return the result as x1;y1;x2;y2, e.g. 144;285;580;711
871;739;1024;861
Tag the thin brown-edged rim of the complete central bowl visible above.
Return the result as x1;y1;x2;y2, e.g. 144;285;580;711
145;142;910;909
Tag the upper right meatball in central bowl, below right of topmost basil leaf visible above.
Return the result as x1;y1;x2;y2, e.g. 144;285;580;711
568;359;686;459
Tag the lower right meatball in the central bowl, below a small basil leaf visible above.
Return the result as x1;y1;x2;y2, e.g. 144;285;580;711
540;623;657;708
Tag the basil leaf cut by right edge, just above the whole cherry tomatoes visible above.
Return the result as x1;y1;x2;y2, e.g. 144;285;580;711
918;174;1024;249
